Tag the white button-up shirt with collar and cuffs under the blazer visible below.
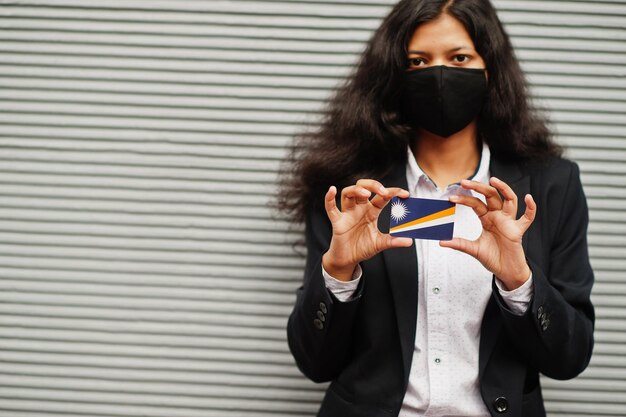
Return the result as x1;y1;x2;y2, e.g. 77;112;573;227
322;144;533;417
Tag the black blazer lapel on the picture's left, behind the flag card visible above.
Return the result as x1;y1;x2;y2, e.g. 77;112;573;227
378;164;418;385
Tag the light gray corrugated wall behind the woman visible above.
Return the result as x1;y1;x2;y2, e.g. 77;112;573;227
0;0;626;417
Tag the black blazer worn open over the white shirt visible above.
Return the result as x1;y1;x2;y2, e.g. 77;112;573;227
287;156;594;417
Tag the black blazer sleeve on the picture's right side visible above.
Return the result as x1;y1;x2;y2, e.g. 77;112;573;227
493;163;595;379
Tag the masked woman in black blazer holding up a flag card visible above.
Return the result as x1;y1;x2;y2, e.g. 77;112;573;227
282;0;594;417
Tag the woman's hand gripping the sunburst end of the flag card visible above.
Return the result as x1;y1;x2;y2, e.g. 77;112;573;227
322;179;413;281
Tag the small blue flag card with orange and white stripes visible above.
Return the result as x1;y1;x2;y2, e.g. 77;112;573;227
389;197;456;240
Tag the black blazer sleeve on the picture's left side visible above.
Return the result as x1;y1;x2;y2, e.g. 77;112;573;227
287;203;364;382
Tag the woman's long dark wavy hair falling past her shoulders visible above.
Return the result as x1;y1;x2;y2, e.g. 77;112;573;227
278;0;562;223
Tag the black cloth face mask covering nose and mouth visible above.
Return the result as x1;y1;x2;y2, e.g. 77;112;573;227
403;65;487;138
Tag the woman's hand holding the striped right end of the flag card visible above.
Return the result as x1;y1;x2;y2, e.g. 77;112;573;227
439;177;537;290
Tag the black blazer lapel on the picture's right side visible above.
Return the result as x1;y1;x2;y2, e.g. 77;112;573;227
479;155;530;379
